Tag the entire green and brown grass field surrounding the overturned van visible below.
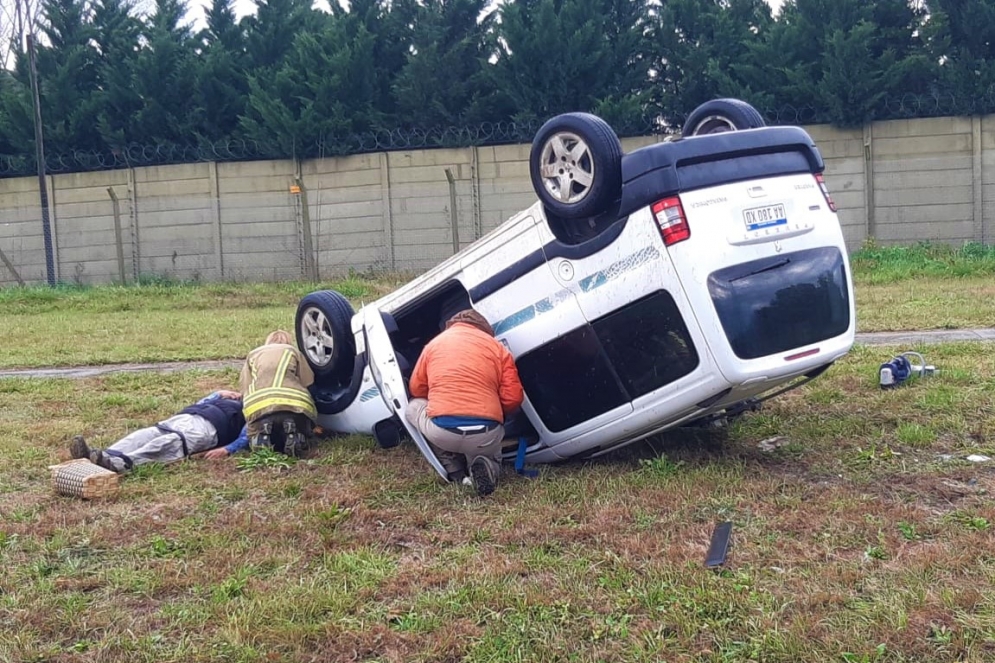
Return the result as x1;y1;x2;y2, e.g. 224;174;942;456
0;247;995;663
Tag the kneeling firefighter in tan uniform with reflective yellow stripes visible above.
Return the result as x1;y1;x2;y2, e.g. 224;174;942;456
239;329;318;456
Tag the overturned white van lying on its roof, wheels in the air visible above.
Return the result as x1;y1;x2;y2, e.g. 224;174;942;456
296;99;854;477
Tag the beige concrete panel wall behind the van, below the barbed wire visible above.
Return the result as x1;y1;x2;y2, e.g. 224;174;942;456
0;116;995;285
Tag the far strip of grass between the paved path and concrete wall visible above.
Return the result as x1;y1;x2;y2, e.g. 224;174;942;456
0;245;995;368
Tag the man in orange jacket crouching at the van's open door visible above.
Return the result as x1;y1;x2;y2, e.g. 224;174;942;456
404;309;524;495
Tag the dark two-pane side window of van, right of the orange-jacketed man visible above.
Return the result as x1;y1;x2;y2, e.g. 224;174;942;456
517;291;699;432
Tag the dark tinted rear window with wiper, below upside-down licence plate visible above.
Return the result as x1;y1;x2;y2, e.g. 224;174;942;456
708;247;850;359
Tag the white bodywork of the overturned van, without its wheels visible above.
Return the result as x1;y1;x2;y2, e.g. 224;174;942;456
314;120;855;476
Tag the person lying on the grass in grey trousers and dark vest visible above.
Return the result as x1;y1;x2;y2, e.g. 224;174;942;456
69;390;248;472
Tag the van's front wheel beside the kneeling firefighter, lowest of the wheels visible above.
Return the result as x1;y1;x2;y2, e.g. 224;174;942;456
295;290;356;378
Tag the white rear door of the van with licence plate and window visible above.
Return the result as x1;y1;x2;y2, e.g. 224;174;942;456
667;174;854;382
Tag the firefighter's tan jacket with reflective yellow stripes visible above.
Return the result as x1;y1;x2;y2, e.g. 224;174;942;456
239;343;318;428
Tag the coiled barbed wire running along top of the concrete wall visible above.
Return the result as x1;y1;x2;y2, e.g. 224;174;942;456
0;89;995;178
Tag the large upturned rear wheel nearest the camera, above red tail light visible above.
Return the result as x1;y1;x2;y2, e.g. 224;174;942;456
529;113;622;219
